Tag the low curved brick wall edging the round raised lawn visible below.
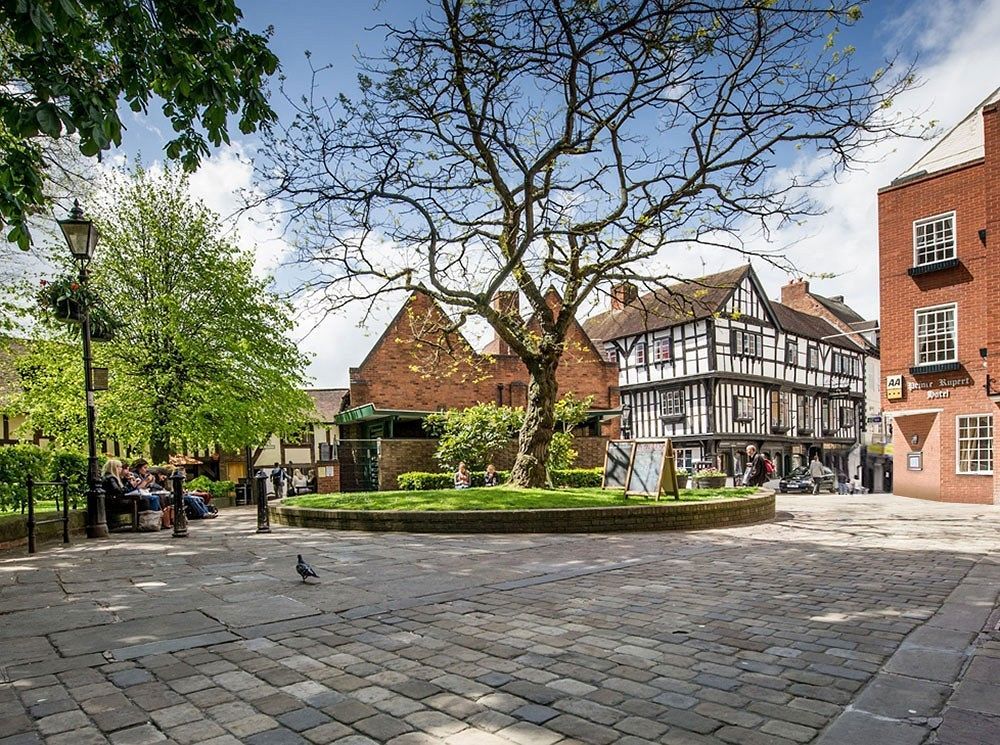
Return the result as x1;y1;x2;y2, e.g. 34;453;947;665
268;491;774;533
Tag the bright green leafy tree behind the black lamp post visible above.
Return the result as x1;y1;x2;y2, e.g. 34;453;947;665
6;168;311;462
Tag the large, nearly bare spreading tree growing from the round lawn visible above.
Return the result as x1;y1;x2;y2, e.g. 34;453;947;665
261;0;912;486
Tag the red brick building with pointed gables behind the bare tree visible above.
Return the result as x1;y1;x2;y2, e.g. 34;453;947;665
335;291;618;491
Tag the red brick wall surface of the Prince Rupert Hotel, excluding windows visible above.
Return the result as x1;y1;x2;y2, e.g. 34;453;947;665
878;101;1000;503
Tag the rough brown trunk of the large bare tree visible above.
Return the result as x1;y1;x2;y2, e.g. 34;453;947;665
510;354;559;488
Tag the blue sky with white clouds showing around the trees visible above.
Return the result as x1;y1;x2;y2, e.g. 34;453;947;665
109;0;1000;387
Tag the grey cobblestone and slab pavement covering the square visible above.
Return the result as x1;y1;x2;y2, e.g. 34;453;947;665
0;495;1000;745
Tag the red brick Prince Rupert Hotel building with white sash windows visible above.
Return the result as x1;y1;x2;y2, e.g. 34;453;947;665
878;89;1000;504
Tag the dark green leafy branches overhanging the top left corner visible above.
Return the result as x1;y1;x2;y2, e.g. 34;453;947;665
0;0;278;248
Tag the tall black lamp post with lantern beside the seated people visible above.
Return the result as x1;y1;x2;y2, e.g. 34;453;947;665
59;200;108;538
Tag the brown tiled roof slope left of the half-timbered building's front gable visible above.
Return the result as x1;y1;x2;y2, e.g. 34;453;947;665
583;264;750;343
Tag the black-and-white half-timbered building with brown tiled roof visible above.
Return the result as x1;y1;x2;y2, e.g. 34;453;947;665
584;265;865;474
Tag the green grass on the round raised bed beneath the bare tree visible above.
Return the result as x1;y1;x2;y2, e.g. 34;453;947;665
283;486;757;512
